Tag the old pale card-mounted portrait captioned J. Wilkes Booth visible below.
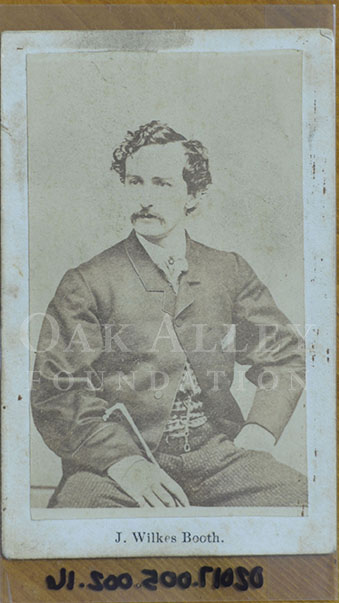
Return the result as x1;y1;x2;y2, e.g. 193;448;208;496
1;29;336;558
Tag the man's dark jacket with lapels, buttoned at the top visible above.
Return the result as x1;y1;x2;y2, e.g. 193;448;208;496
32;231;304;472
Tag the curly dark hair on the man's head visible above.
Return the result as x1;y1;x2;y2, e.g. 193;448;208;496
111;120;212;197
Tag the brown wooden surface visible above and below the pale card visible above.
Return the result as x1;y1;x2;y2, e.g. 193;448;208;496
0;0;339;603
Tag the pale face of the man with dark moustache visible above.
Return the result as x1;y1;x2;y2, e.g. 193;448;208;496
125;142;194;238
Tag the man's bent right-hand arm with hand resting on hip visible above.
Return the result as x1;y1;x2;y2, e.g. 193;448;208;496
233;256;305;450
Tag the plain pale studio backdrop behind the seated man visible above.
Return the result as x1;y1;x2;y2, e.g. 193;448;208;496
27;51;306;505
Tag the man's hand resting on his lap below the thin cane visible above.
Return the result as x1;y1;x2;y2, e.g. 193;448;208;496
107;456;189;507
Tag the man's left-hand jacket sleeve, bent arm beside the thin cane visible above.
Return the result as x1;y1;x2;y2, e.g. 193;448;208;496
31;269;143;472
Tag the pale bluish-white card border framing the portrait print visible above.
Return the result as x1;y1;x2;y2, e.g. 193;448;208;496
1;29;336;558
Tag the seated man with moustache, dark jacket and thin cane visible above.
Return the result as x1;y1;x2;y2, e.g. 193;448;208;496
32;121;307;507
